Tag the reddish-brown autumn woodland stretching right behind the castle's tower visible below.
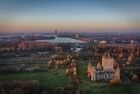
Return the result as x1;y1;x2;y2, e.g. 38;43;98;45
79;45;140;64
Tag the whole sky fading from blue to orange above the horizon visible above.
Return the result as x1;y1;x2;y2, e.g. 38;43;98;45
0;0;140;32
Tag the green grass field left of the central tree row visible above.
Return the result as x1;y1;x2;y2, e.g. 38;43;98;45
0;70;69;91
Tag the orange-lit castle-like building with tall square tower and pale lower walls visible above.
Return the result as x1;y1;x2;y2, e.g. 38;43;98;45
87;53;120;81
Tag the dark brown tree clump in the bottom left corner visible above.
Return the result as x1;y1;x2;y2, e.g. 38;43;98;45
0;80;39;94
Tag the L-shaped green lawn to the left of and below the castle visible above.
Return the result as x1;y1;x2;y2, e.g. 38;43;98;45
78;64;140;94
